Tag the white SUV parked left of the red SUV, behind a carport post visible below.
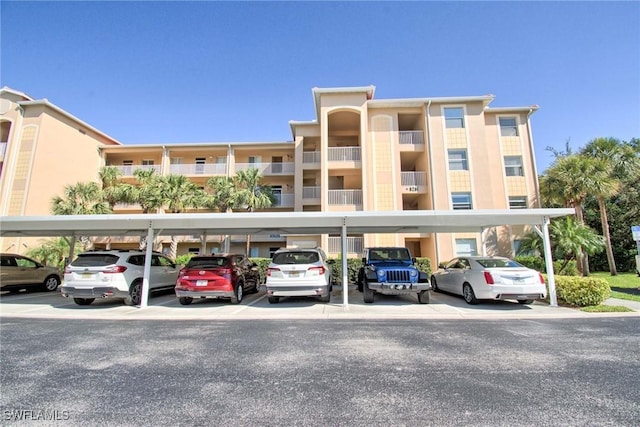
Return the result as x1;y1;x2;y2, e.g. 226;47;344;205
60;250;179;305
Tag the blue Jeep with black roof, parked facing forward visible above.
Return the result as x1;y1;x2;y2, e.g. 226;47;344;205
358;247;431;304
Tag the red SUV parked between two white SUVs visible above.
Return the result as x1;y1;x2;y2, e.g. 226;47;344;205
175;254;260;305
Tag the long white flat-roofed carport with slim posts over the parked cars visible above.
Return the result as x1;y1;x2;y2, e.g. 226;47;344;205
0;209;574;310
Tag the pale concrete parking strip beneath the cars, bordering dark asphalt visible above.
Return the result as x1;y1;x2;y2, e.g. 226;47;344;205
0;286;640;320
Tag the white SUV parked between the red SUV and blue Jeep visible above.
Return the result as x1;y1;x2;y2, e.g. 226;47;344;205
266;248;332;304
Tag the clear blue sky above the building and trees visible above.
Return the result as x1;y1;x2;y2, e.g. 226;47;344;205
0;0;640;172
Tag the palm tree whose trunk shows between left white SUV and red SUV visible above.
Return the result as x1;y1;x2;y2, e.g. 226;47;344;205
159;174;207;259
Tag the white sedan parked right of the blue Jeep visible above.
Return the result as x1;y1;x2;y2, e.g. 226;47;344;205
431;256;547;304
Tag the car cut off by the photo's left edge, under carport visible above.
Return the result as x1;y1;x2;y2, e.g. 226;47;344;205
0;254;61;292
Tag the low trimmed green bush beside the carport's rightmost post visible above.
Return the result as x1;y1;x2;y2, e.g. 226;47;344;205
545;276;611;307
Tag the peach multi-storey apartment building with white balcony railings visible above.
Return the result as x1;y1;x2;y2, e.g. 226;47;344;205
0;86;539;262
